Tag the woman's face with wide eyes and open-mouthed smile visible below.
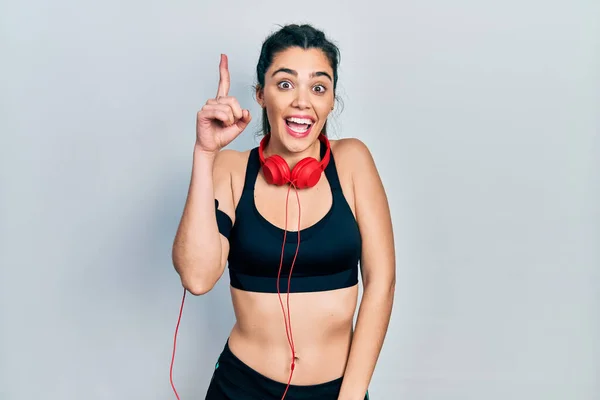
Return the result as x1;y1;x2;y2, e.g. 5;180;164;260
257;47;334;152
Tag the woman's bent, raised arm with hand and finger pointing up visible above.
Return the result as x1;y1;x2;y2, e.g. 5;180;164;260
172;55;251;295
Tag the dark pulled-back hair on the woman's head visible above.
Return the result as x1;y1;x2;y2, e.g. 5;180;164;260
256;24;340;135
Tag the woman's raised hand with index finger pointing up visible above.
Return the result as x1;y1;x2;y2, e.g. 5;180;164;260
196;54;252;153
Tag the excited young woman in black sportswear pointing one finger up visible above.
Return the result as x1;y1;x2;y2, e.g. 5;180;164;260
173;25;395;400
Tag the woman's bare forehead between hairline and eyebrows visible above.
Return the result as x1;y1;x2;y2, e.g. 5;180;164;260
267;47;333;76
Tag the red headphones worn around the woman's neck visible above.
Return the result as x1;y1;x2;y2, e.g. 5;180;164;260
258;134;331;189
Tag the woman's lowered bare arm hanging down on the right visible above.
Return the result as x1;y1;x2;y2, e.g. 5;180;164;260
338;139;396;400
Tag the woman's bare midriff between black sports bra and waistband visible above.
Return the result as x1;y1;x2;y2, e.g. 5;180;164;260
229;285;358;385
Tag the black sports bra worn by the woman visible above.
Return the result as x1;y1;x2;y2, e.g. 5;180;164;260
215;143;362;293
